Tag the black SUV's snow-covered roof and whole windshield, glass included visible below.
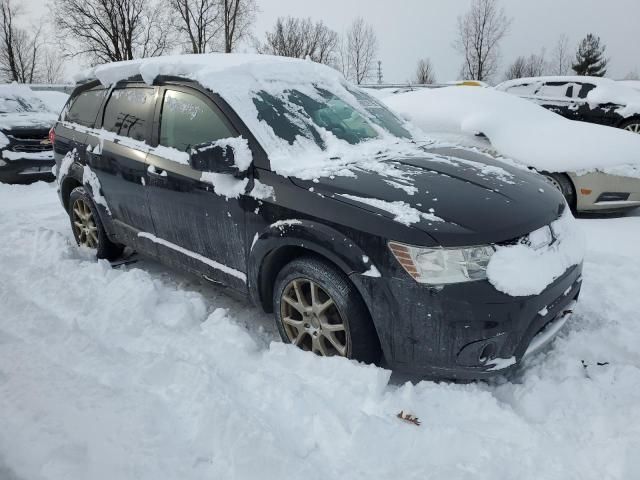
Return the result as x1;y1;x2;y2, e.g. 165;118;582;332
77;54;425;178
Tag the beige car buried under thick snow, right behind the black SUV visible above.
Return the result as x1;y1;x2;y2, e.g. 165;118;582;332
384;87;640;212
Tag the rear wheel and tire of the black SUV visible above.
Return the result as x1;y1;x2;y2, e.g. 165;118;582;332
69;187;124;260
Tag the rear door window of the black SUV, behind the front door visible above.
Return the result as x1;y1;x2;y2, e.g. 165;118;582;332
102;87;155;141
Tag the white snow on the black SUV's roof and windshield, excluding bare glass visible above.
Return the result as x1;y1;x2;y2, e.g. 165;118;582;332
77;54;424;179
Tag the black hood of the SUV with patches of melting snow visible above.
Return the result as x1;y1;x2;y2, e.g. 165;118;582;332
292;147;565;246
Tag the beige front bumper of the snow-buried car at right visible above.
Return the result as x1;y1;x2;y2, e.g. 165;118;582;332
569;172;640;213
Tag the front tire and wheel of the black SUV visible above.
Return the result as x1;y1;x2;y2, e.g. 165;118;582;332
273;257;381;363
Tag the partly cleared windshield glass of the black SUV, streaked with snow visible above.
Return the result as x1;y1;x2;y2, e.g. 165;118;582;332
253;86;411;150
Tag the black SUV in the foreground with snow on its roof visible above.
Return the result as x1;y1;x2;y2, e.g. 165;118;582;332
53;55;582;378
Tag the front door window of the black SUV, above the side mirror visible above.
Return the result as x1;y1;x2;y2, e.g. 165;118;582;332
159;90;237;152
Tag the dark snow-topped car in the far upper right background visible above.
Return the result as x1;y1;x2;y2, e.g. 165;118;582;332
496;76;640;133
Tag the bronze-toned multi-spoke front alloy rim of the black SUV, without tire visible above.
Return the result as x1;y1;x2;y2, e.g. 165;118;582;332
280;278;349;357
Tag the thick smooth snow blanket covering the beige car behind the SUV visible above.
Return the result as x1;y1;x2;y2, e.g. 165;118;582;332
385;87;640;178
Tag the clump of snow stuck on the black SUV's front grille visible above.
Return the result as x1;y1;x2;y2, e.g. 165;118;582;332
487;207;585;297
